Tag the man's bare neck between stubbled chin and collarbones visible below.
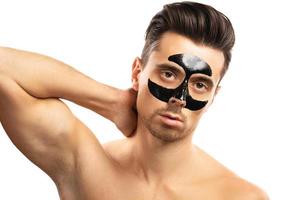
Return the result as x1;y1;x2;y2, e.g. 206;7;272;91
129;119;196;182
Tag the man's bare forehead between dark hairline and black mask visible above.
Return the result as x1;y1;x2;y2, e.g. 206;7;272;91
148;32;224;82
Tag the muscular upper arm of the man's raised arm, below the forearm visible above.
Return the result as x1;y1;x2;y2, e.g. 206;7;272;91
0;75;78;178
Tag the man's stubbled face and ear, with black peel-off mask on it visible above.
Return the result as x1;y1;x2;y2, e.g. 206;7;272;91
133;32;224;142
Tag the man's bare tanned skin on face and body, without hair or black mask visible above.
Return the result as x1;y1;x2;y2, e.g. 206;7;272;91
0;32;267;200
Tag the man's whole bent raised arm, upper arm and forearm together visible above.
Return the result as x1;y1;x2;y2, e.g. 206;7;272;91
0;48;133;183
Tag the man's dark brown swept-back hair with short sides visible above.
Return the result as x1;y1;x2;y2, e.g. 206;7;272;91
141;1;235;78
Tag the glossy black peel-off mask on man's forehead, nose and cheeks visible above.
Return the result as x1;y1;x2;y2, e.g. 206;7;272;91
148;54;212;111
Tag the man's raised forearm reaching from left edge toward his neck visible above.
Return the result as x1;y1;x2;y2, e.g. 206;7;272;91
0;47;120;119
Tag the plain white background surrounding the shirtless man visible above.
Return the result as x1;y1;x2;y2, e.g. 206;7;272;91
0;0;300;200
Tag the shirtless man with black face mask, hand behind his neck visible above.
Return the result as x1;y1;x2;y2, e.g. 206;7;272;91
0;2;267;200
